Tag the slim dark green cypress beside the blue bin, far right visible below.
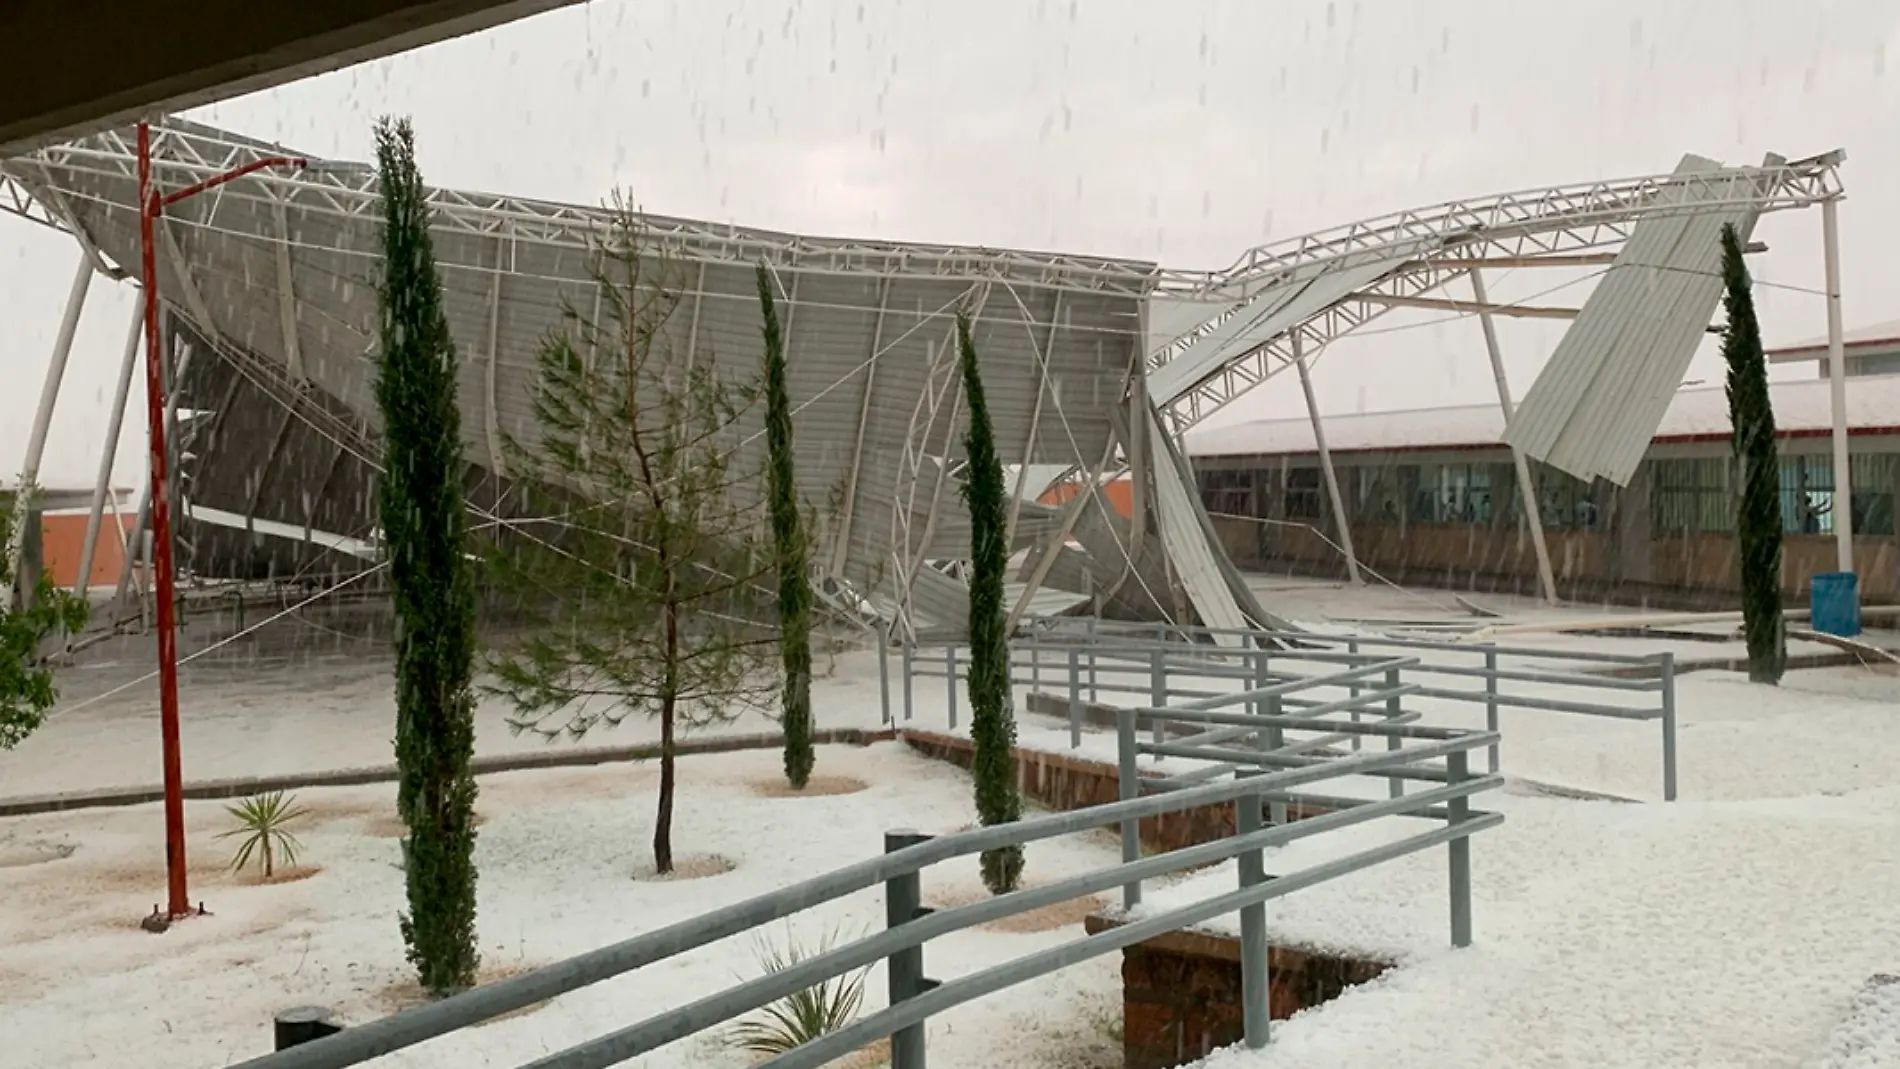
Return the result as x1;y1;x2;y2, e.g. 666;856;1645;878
1721;226;1788;684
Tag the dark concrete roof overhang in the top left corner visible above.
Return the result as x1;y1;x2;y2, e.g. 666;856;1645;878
0;0;578;156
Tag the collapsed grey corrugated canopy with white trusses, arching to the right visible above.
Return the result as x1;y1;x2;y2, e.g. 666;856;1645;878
0;122;1841;632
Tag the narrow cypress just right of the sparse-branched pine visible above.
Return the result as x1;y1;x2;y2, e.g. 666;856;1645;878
758;264;815;790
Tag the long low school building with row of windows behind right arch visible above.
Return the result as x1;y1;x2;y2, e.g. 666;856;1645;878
1188;362;1900;608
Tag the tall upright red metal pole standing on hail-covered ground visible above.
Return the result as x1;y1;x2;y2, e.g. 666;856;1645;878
139;123;192;917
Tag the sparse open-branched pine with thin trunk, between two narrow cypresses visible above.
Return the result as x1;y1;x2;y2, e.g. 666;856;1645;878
488;209;779;873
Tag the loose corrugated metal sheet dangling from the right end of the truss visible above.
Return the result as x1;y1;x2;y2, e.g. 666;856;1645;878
1505;156;1778;484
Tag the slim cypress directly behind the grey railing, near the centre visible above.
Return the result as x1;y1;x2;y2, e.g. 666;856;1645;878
956;311;1022;894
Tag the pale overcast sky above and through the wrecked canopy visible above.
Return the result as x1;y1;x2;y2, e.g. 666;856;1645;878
0;0;1900;486
